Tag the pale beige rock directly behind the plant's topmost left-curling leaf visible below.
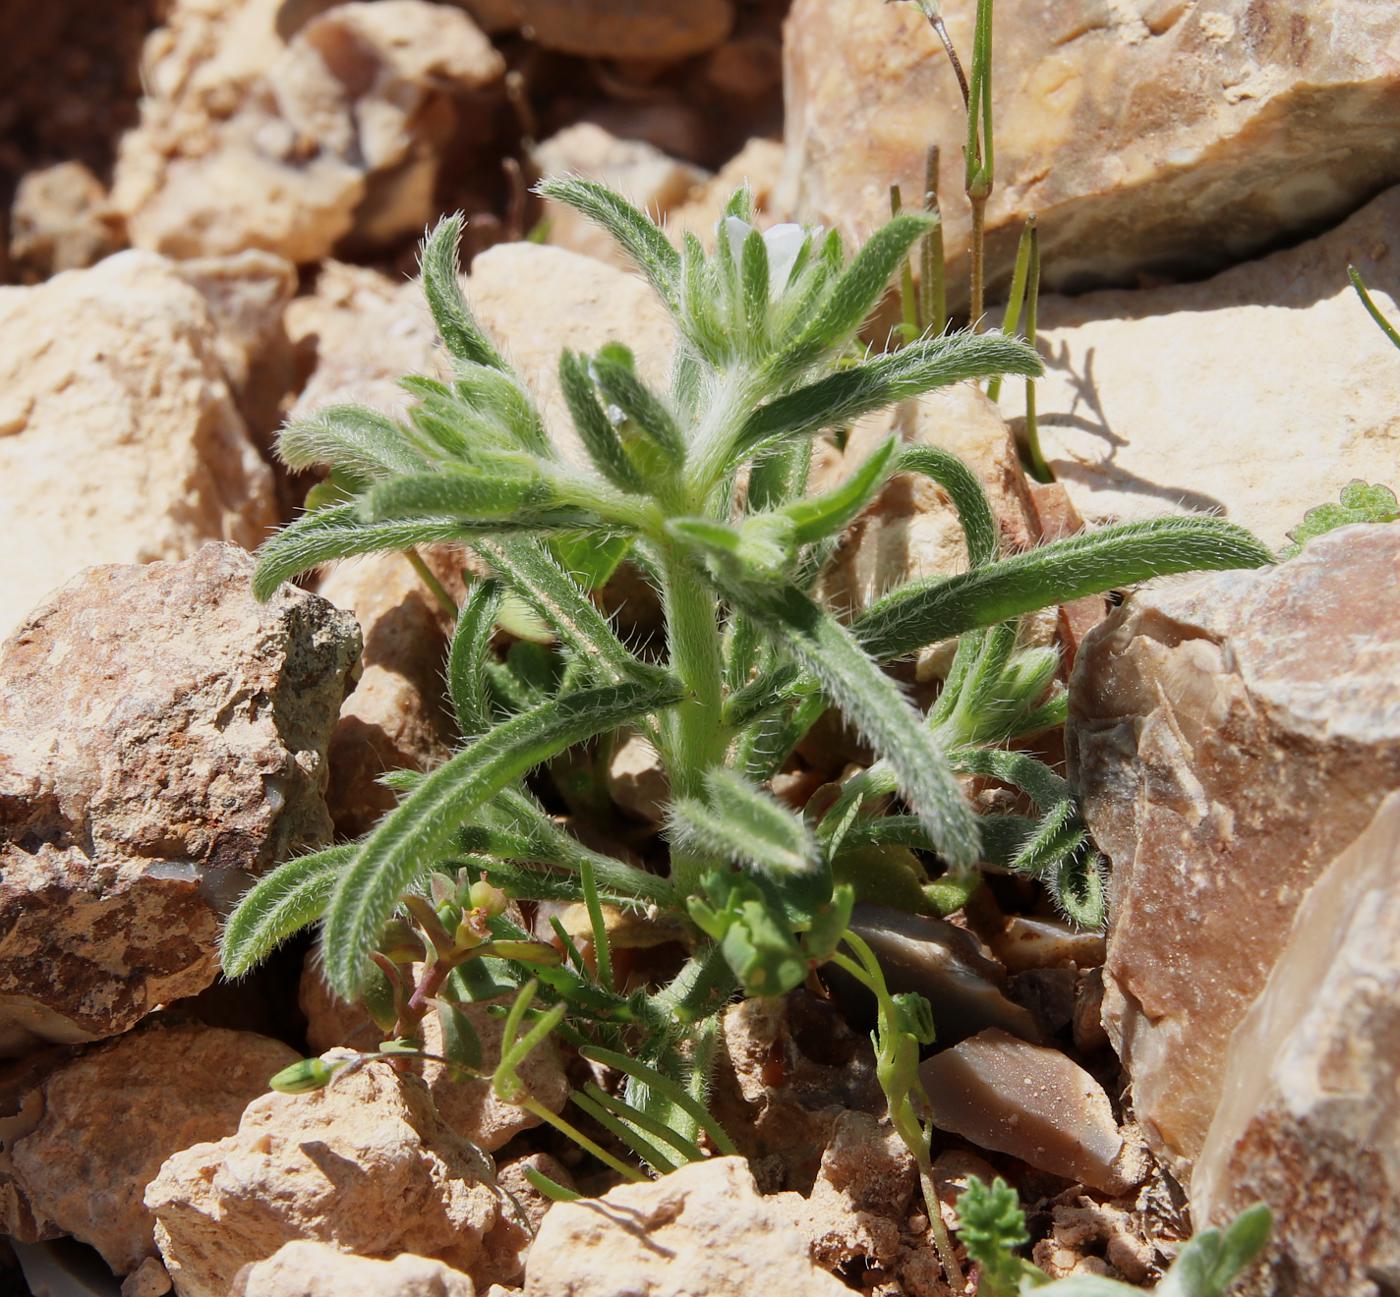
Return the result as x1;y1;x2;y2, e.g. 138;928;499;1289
533;122;707;270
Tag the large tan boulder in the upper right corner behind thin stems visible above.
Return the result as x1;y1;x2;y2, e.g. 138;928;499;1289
784;0;1400;302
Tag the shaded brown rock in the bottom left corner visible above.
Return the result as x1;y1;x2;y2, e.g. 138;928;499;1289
0;1022;297;1275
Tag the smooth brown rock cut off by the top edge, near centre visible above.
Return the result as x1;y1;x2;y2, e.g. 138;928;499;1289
517;0;734;60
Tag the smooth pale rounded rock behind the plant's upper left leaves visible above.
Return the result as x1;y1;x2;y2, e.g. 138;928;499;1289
466;242;675;464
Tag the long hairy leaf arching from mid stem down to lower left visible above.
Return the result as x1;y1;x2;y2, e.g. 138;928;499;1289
322;679;680;1000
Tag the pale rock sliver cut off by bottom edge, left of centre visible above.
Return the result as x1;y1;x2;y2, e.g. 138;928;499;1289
228;1240;476;1297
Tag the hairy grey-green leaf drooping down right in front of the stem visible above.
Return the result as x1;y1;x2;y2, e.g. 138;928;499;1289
727;585;979;870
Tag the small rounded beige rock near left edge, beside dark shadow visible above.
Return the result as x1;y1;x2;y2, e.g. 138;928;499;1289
10;162;123;280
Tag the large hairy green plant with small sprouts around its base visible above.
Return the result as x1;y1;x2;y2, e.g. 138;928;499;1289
223;179;1271;1275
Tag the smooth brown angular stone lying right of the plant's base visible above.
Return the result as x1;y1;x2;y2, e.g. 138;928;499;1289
918;1027;1127;1193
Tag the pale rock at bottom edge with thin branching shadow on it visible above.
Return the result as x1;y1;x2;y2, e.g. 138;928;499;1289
525;1157;850;1297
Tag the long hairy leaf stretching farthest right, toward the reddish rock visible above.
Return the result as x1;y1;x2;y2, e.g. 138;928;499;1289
853;518;1274;661
